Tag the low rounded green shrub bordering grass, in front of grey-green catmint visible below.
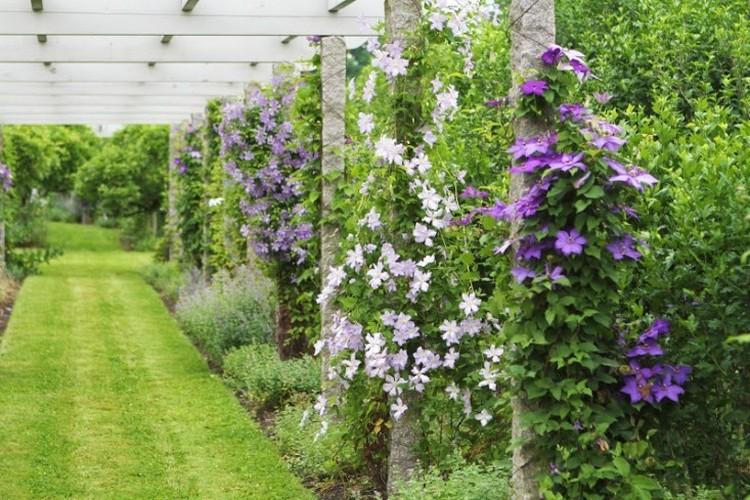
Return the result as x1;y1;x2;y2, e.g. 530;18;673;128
224;344;321;409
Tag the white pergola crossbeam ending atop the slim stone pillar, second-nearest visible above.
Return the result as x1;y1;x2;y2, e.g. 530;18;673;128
0;36;313;63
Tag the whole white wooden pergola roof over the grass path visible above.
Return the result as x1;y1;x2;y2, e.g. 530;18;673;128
0;0;384;125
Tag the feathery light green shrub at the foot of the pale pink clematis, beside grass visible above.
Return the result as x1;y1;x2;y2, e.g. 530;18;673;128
273;398;357;484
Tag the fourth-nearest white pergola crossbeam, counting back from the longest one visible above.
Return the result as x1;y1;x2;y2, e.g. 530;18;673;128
0;81;247;99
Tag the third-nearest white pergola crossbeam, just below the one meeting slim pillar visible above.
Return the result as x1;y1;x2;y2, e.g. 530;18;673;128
0;62;281;84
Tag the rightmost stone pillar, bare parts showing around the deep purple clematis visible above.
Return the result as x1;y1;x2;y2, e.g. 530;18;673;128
510;0;555;500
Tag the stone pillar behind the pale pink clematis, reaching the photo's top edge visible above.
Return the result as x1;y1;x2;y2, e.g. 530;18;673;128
385;0;423;496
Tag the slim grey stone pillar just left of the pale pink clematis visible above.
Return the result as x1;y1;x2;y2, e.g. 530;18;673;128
320;37;346;400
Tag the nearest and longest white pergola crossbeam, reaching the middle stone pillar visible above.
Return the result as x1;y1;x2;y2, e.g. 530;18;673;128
0;12;382;37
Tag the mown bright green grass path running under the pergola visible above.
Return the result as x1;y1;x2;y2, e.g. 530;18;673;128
0;224;312;500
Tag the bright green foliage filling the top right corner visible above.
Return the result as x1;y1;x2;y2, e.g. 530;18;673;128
556;0;750;118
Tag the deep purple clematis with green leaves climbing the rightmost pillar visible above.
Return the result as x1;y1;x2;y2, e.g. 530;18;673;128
494;46;690;498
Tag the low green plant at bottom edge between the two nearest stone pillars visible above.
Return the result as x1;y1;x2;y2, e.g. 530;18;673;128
395;456;511;500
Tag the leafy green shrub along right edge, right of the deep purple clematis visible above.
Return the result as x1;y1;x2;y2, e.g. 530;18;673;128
628;97;750;494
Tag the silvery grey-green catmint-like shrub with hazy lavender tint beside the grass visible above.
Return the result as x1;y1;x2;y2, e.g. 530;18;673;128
176;268;274;365
